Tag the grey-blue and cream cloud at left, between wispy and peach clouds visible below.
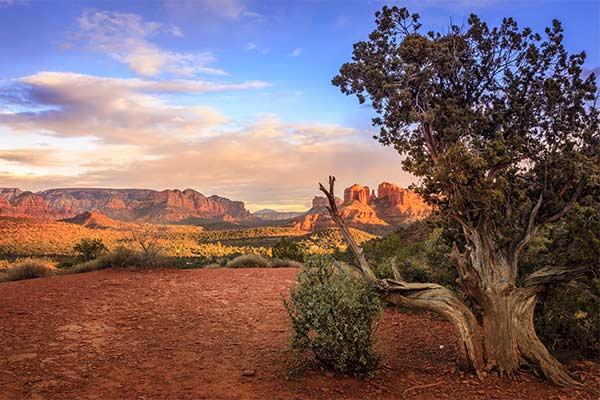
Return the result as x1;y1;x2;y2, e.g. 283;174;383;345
0;72;268;144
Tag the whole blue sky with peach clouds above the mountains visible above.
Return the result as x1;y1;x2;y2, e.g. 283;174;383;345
0;0;600;211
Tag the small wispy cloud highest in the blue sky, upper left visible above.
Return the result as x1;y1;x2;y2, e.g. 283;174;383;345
70;10;228;77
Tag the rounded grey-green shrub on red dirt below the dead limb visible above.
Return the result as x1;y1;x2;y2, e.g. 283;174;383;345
284;256;383;375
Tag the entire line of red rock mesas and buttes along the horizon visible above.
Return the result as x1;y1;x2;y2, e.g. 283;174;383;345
0;182;431;232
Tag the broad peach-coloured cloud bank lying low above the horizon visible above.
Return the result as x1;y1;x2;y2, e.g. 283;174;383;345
0;117;412;209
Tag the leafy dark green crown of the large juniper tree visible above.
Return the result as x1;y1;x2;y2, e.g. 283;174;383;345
333;6;600;241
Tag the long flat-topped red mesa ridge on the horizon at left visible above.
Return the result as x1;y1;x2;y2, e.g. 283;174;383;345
0;188;252;223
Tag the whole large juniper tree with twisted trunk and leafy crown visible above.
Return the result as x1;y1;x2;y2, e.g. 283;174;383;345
321;7;600;384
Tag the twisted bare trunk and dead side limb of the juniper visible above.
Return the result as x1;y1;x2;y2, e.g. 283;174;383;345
319;176;583;385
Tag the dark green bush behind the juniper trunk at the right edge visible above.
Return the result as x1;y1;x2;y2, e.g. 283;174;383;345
522;203;600;358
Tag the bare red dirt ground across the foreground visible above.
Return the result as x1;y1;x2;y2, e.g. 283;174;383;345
0;269;600;400
